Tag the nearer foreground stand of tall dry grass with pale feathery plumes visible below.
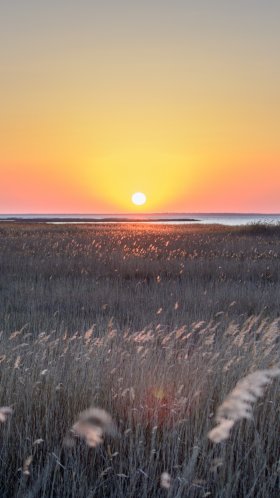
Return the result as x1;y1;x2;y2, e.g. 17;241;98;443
0;317;280;497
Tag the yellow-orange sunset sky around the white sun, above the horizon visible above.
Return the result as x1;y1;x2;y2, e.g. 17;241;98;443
0;0;280;213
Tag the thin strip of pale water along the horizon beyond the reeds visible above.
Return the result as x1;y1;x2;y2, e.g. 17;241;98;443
0;213;280;226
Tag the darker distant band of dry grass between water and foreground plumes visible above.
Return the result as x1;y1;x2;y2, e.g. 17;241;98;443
0;223;280;334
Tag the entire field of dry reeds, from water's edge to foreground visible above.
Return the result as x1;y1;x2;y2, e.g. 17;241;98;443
0;223;280;498
